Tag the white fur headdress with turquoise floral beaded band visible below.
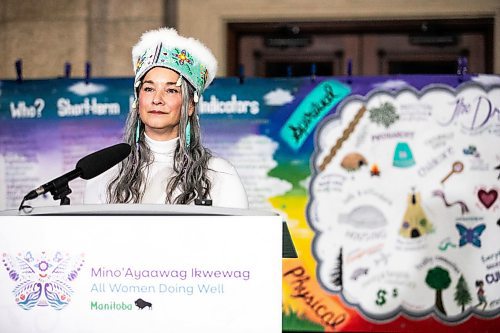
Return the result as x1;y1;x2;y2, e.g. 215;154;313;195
132;28;217;95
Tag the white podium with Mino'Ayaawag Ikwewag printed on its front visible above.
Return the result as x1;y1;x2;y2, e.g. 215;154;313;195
0;205;296;333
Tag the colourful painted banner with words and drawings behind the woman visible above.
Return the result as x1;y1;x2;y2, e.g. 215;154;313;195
0;75;500;332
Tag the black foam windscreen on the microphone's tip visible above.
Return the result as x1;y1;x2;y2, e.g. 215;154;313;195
76;143;131;179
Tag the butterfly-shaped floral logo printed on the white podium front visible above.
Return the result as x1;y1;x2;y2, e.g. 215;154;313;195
2;251;85;310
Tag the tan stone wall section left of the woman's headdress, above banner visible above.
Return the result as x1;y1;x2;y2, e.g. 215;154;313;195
0;0;165;79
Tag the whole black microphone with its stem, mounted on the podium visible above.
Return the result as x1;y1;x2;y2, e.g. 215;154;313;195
24;143;131;200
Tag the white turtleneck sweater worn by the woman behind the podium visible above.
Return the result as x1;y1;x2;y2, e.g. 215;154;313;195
84;136;252;209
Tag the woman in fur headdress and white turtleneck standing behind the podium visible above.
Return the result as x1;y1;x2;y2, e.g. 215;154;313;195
84;28;248;209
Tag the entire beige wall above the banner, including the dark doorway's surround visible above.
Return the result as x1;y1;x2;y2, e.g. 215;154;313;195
0;0;500;79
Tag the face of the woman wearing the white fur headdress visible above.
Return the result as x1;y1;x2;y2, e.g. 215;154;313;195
139;67;188;141
